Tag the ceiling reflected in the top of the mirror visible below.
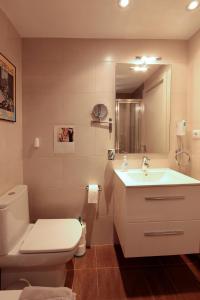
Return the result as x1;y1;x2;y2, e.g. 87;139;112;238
115;63;163;93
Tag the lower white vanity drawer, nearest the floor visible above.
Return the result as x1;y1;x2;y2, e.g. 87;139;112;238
123;221;200;257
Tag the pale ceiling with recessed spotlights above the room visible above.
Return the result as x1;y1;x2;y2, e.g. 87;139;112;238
0;0;200;39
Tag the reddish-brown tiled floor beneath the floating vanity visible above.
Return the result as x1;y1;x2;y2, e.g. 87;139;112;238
66;245;200;300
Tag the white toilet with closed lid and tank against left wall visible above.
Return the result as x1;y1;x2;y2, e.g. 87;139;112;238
0;185;82;289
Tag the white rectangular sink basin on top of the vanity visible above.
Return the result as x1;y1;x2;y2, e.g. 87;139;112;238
114;168;200;187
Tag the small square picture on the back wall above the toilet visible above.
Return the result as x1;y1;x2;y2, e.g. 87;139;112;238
54;125;75;153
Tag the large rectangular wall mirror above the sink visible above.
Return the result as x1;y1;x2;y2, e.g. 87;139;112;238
115;63;171;153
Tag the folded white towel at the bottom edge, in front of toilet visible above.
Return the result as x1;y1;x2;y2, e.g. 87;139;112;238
19;286;76;300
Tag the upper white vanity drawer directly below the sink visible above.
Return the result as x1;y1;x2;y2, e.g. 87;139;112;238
125;186;200;222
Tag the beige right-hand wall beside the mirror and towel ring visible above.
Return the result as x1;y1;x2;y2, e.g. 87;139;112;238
188;31;200;179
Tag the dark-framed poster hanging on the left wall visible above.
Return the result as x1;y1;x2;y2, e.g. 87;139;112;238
0;53;16;122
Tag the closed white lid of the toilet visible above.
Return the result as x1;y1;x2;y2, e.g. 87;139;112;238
20;219;82;253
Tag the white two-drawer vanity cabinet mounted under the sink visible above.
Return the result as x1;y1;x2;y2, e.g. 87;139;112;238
114;176;200;257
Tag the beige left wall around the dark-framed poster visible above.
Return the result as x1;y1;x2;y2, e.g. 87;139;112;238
0;10;23;195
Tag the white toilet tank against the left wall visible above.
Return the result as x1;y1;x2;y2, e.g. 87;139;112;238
0;185;29;255
